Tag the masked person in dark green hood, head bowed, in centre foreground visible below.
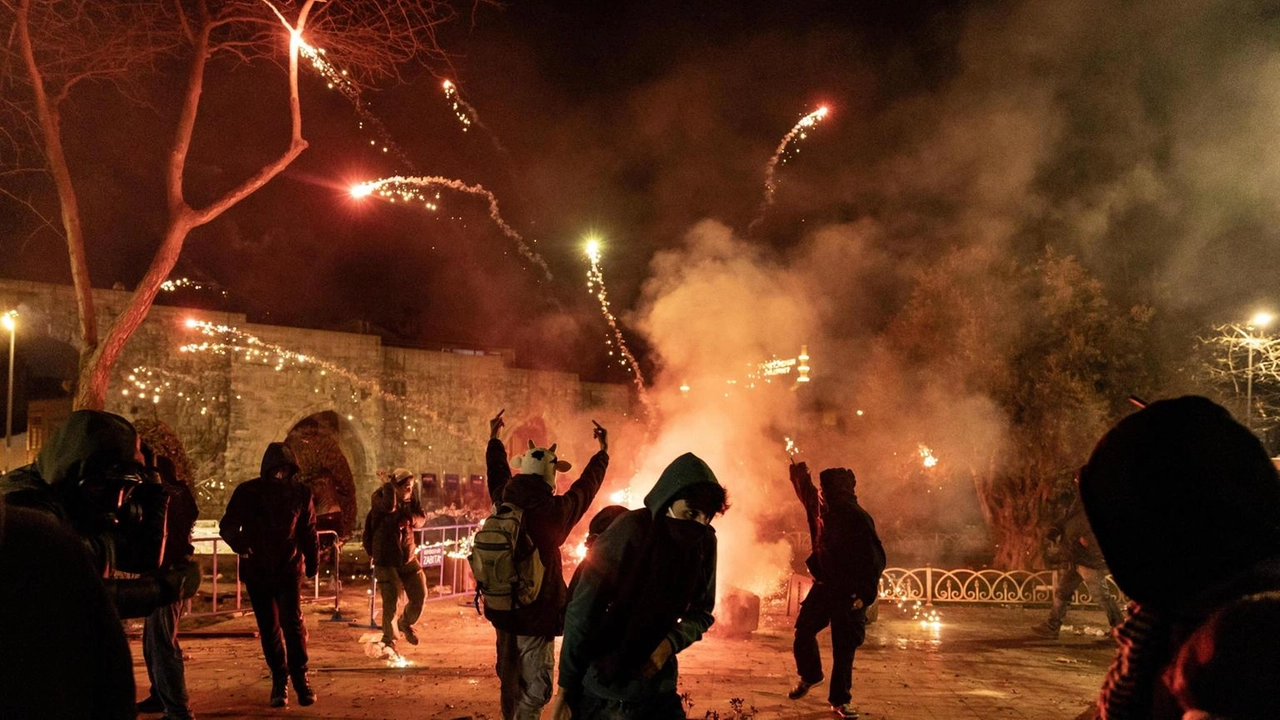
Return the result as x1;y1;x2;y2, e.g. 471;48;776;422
552;452;728;720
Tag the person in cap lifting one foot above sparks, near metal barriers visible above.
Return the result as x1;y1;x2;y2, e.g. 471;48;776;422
366;468;426;648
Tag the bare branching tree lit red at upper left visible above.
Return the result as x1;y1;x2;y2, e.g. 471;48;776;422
0;0;471;407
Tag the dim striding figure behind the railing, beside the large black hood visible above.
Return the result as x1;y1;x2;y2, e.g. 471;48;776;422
1032;473;1124;638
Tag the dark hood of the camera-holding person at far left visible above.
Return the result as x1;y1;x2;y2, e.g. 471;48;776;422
36;410;142;489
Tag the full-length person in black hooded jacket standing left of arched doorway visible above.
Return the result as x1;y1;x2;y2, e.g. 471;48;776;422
219;442;317;707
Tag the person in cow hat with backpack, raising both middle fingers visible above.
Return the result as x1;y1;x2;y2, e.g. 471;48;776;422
481;411;609;720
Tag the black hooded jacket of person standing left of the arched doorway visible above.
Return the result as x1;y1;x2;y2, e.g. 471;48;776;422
218;442;317;582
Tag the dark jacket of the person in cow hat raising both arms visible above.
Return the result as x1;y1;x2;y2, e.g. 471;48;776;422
485;438;609;638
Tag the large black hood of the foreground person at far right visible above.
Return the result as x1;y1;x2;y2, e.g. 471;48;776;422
1080;396;1280;611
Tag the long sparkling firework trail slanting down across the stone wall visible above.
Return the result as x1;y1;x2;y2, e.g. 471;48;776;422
178;318;471;442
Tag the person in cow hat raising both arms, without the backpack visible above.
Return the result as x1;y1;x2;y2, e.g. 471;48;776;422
485;411;609;720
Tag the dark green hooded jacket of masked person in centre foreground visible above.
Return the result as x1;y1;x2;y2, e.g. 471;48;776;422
558;452;719;702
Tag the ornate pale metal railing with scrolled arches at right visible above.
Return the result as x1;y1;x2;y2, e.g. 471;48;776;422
879;566;1125;605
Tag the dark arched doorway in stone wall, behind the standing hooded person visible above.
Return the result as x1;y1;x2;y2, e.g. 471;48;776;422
284;410;365;538
